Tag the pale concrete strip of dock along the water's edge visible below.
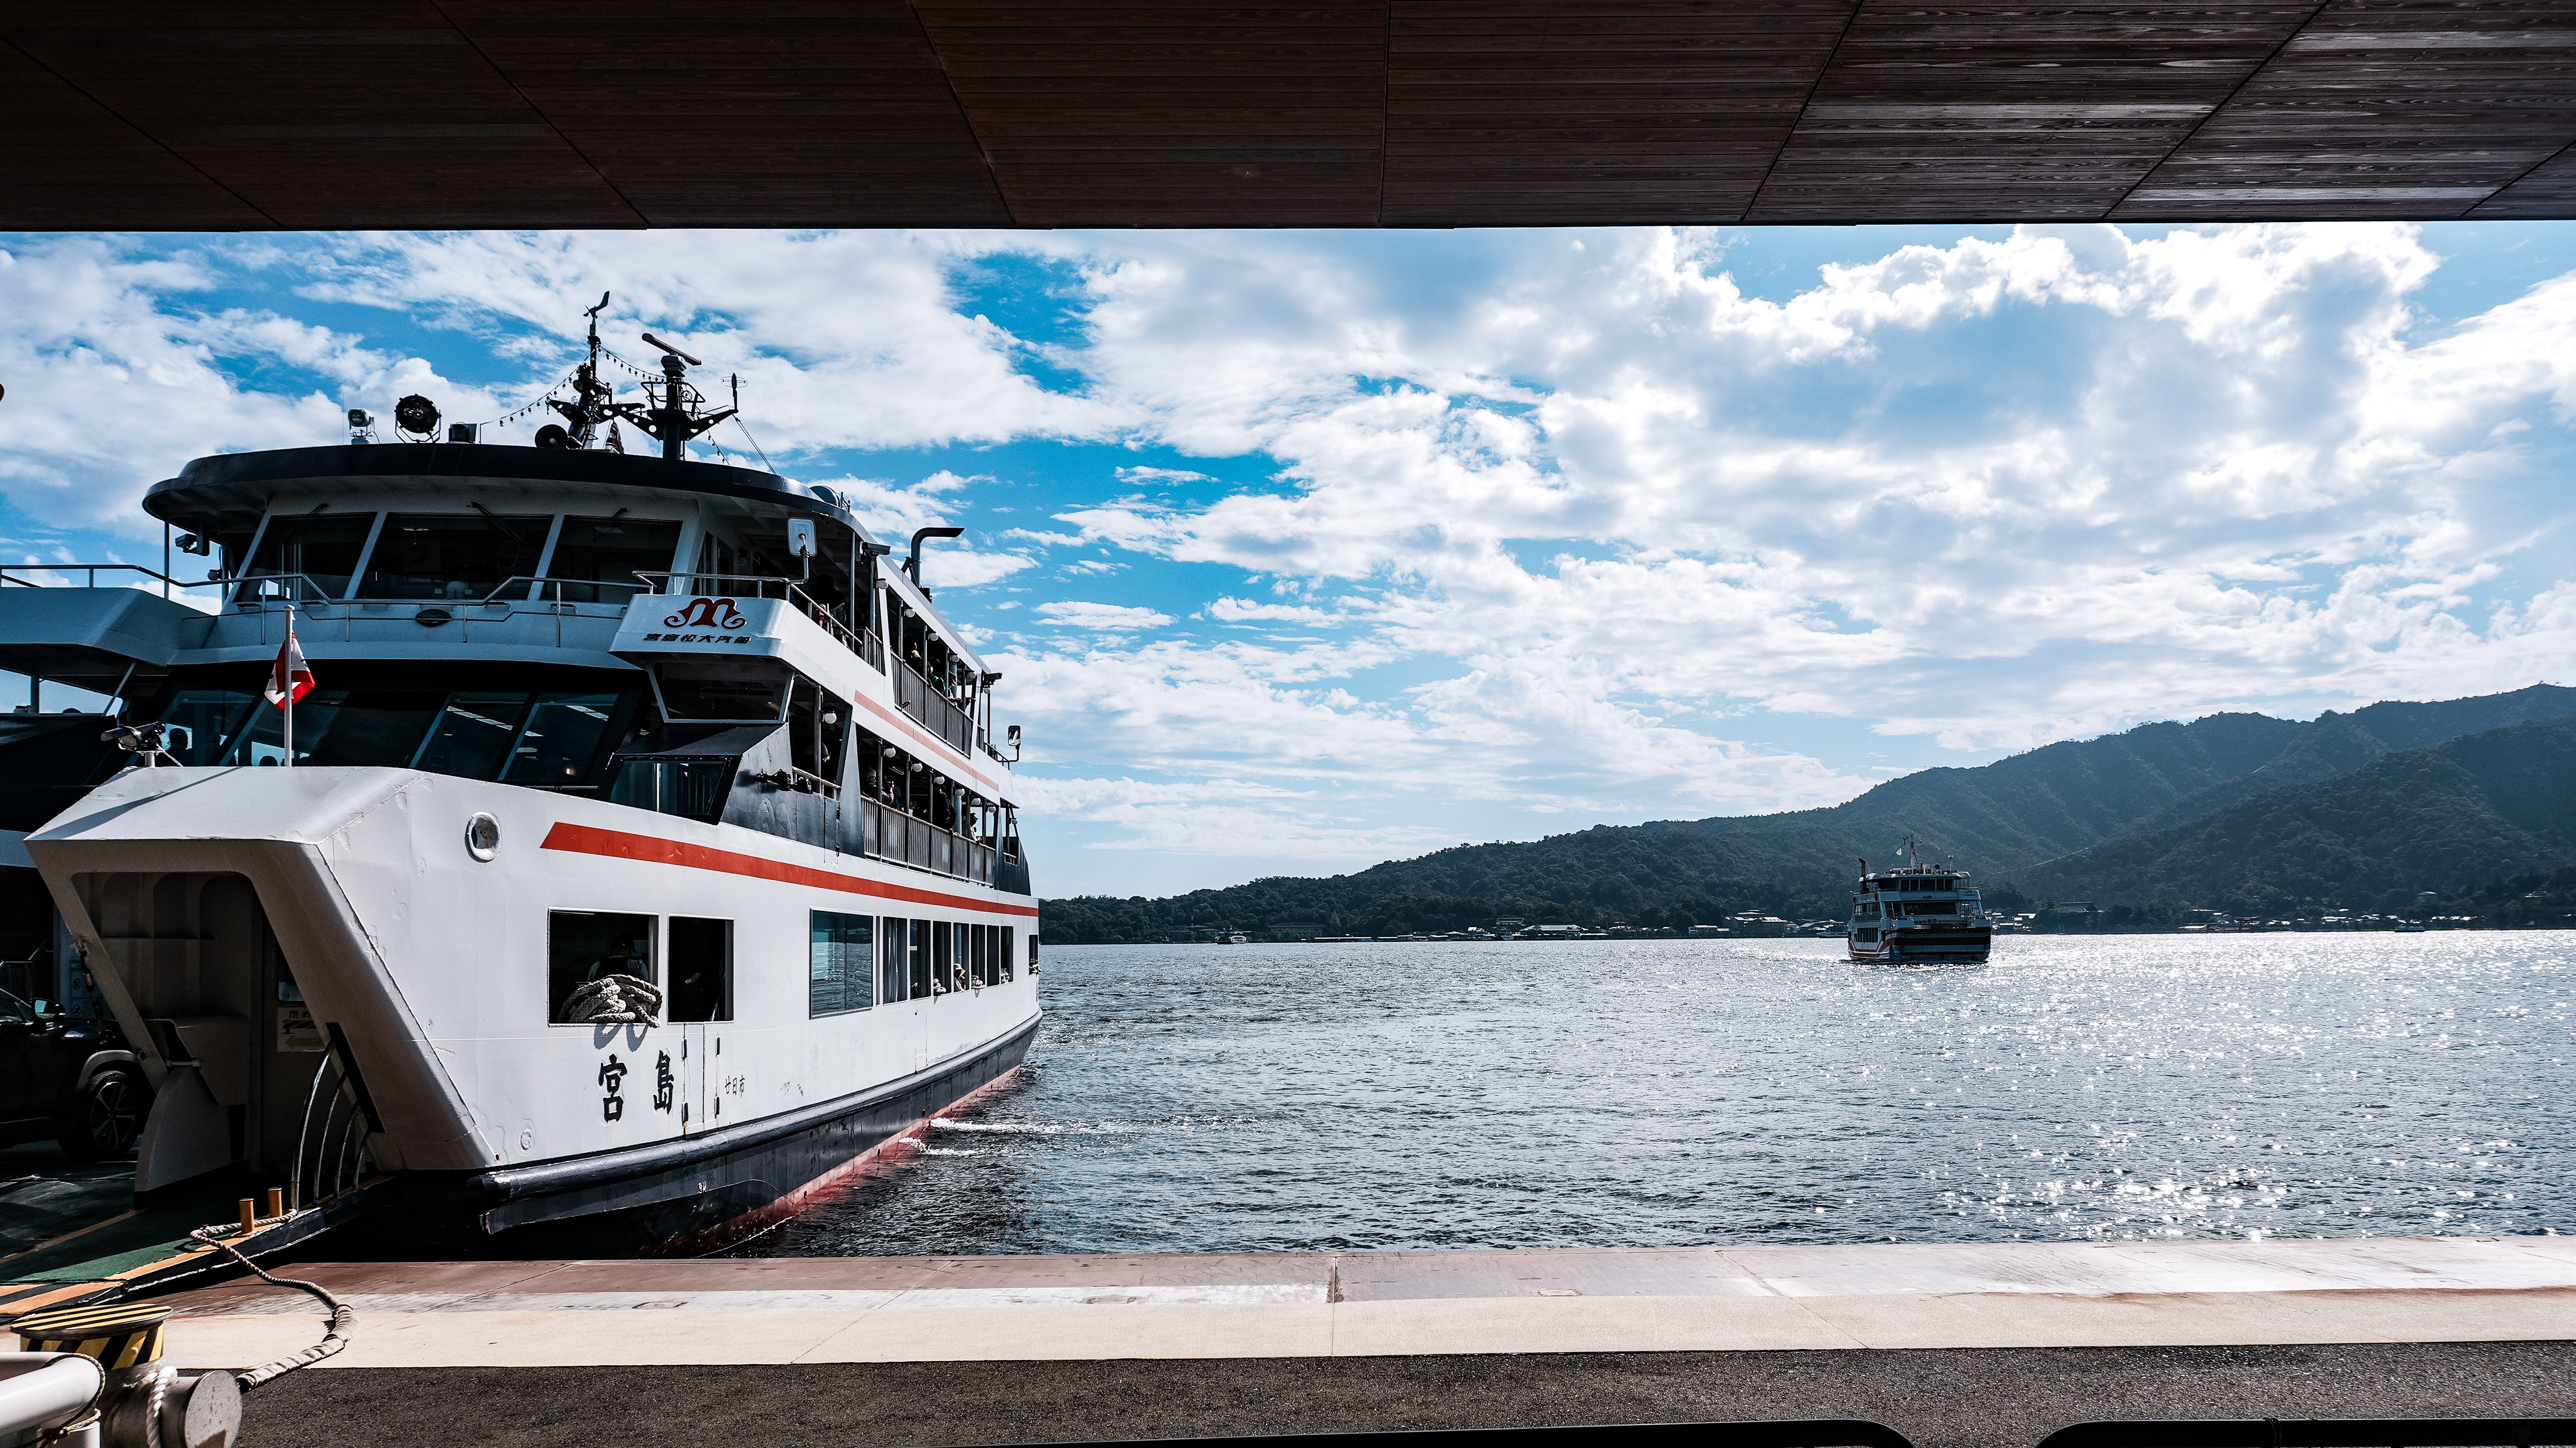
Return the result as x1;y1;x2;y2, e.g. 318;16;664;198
157;1237;2576;1371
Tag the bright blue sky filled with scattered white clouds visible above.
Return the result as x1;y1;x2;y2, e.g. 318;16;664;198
0;222;2576;894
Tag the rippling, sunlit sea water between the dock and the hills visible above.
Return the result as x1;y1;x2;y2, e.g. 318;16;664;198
744;933;2576;1255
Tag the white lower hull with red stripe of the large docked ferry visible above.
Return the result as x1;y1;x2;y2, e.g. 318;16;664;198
28;768;1041;1252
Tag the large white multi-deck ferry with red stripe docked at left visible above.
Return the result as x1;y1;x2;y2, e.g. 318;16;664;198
0;313;1038;1247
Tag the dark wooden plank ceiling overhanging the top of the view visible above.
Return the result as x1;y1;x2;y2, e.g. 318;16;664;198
0;0;2576;232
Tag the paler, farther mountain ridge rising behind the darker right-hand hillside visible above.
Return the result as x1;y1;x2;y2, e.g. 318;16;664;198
1043;686;2576;941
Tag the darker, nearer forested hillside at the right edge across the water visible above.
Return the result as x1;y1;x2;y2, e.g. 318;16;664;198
2025;719;2576;912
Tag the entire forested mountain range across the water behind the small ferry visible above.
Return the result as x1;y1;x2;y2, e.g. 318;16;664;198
1043;686;2576;943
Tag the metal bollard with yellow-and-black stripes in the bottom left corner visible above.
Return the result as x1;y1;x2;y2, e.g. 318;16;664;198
10;1304;242;1448
